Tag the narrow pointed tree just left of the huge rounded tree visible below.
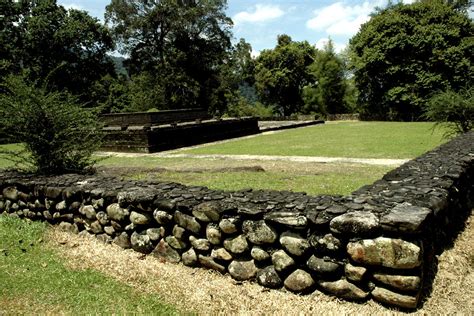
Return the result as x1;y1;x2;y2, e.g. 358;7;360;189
303;40;347;114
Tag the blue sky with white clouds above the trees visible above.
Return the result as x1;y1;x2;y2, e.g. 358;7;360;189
58;0;413;55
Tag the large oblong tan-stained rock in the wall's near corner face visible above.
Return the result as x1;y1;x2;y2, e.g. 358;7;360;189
347;237;422;269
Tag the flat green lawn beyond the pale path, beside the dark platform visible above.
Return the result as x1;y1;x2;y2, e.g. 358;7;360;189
183;122;446;159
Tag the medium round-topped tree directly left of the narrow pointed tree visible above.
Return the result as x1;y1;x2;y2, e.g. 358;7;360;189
255;35;316;116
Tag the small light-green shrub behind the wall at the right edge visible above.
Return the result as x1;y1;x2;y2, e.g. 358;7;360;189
425;87;474;136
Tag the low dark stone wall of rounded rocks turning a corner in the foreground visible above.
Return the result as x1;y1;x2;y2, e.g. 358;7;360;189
0;132;474;309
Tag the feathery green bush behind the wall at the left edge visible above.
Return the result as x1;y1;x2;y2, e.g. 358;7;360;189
0;76;102;174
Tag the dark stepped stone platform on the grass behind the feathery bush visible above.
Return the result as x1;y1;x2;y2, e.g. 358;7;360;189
102;109;260;153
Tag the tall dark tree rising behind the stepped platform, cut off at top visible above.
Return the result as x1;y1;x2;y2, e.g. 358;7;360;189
106;0;232;112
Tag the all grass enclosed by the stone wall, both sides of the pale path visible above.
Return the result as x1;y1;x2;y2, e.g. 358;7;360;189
0;122;445;194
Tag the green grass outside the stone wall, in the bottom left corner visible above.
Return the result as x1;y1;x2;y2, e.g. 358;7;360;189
0;215;178;315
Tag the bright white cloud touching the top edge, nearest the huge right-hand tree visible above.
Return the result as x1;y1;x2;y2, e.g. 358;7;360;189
306;0;386;36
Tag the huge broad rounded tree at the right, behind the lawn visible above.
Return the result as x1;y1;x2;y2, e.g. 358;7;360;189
350;0;474;120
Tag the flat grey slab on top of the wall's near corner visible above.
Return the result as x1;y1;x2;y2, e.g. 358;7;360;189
380;203;431;233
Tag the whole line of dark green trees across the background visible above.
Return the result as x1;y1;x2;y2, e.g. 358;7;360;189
0;0;474;121
